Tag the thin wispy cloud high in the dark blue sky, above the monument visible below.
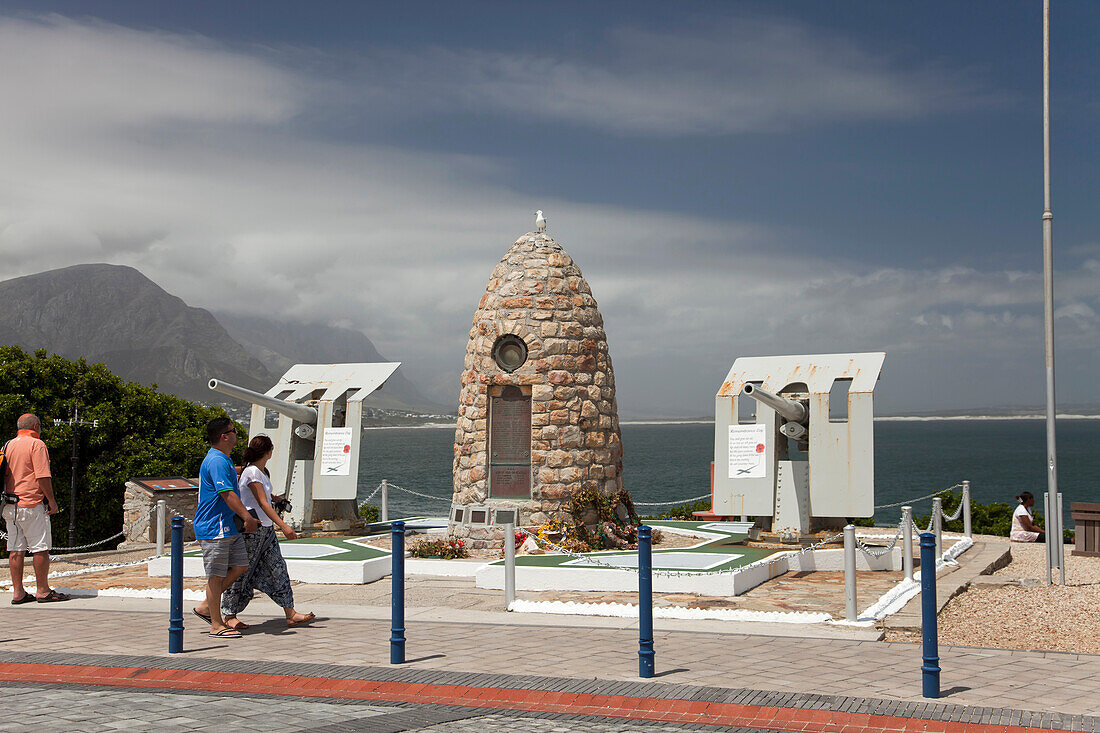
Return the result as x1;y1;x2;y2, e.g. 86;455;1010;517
341;18;998;135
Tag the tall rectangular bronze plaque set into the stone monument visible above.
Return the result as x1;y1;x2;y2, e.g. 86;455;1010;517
488;386;531;499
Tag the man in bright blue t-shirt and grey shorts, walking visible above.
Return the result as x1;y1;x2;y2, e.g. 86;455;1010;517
194;417;260;638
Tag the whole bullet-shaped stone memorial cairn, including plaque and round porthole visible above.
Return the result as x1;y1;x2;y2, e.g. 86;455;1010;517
450;232;637;548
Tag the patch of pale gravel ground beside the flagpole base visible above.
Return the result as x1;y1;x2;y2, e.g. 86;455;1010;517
939;543;1100;654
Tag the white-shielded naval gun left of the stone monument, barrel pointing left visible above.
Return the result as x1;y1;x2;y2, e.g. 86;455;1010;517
209;362;400;530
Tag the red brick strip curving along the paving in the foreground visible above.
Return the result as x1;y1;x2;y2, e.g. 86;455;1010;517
0;663;1064;733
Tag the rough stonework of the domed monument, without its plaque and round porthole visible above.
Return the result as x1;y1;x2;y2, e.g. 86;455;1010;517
452;232;623;546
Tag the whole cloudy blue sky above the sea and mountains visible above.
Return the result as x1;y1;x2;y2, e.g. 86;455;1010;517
0;0;1100;417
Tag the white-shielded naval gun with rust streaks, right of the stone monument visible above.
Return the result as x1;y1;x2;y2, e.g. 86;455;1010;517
711;352;886;540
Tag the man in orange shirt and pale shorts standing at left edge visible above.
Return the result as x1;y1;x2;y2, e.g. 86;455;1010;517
3;415;68;605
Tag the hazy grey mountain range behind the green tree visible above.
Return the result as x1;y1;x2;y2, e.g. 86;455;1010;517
0;264;453;414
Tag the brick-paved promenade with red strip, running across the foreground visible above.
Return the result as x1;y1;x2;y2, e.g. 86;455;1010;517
0;594;1100;732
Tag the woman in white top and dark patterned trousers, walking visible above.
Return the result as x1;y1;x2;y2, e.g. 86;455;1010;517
221;435;315;628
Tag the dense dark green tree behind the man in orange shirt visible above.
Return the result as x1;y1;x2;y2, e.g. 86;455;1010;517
0;346;248;549
